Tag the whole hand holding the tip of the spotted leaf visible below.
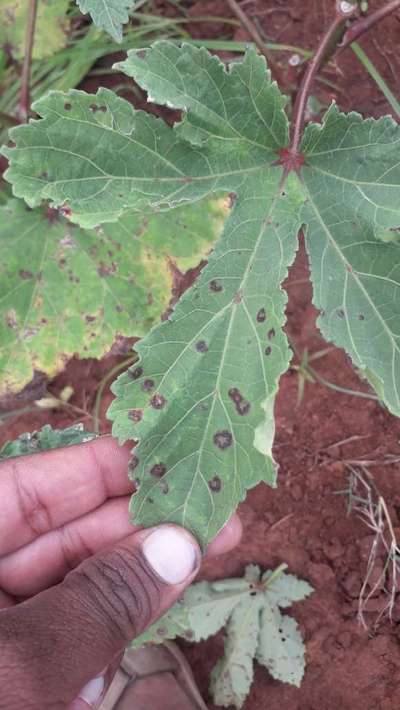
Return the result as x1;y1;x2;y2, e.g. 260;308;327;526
0;437;241;710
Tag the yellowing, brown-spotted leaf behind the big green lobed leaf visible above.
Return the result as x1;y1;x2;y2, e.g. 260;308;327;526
0;200;222;394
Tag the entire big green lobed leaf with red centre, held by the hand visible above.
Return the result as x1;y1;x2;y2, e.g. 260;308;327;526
4;42;400;545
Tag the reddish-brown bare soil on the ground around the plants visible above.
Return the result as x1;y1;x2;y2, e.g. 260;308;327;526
0;0;400;710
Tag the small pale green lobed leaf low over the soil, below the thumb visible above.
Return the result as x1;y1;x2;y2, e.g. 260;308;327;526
132;565;313;708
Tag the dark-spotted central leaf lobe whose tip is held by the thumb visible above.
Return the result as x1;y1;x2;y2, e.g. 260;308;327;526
109;171;299;545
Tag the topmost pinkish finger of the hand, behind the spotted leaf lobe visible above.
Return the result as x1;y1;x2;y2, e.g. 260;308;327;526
0;436;133;555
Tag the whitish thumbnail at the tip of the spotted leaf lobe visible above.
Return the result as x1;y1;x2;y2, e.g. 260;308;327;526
143;525;199;584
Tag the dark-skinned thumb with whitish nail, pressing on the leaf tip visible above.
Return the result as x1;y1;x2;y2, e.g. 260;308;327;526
0;525;201;710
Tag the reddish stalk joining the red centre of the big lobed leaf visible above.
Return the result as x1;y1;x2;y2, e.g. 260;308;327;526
290;6;356;155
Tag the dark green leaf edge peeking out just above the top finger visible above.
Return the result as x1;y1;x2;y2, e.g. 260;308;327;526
0;424;96;461
